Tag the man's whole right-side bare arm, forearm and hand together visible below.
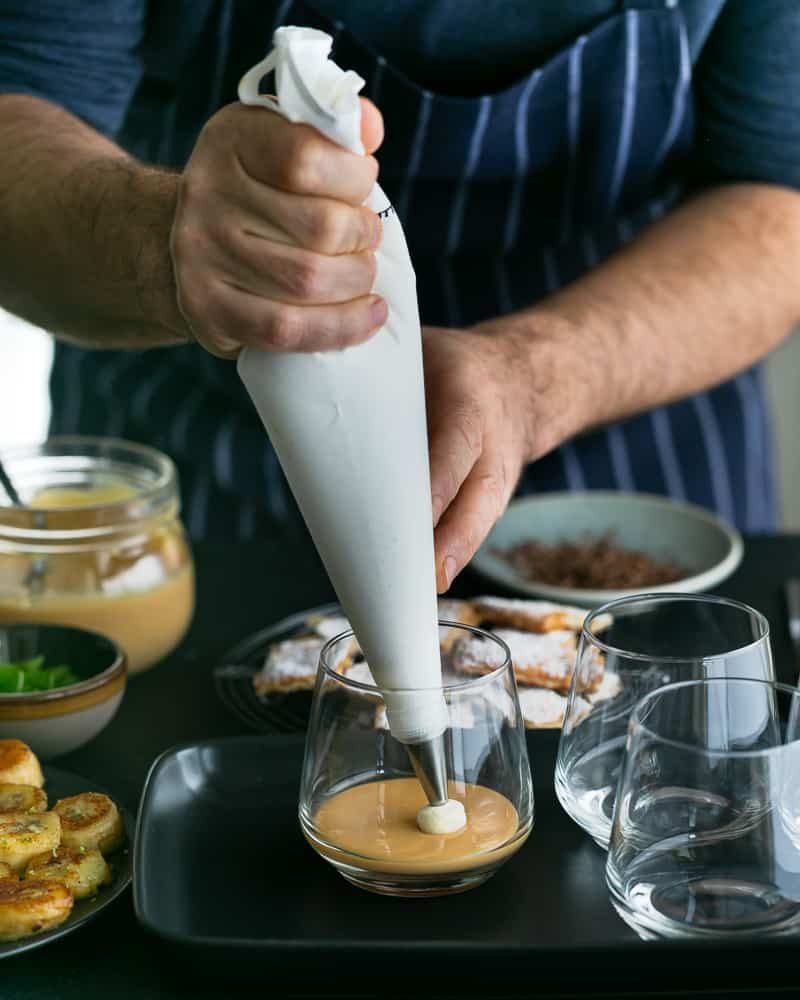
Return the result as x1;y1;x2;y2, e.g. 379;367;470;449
423;184;800;590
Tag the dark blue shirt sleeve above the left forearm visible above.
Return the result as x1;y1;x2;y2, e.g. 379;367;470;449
0;0;147;136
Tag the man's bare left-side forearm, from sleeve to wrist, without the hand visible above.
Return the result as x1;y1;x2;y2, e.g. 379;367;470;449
0;95;187;347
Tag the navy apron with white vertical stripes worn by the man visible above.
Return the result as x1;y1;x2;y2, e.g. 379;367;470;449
52;0;776;538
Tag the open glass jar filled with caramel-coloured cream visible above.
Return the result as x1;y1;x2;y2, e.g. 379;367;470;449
0;437;194;673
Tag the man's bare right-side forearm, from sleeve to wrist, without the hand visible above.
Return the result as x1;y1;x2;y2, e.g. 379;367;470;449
489;185;800;454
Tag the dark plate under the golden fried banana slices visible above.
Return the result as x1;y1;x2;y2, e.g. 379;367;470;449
0;765;135;959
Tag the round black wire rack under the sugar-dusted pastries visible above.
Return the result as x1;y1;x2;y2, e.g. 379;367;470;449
214;604;342;733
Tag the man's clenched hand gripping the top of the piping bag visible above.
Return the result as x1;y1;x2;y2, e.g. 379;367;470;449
171;100;386;357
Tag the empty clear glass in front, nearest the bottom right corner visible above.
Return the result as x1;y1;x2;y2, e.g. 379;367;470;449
606;678;800;938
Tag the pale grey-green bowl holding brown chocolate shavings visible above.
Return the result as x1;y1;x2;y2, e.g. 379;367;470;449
471;490;744;608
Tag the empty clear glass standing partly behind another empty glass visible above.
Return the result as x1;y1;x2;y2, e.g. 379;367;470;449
555;594;775;848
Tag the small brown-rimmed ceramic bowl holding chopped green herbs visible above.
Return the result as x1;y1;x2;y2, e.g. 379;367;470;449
0;624;127;760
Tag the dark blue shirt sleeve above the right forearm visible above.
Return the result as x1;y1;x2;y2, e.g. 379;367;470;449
695;0;800;188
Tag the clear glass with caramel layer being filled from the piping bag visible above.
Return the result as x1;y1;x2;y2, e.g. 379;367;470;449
299;622;533;896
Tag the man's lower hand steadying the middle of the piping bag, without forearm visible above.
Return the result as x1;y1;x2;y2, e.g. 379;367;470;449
423;327;542;592
